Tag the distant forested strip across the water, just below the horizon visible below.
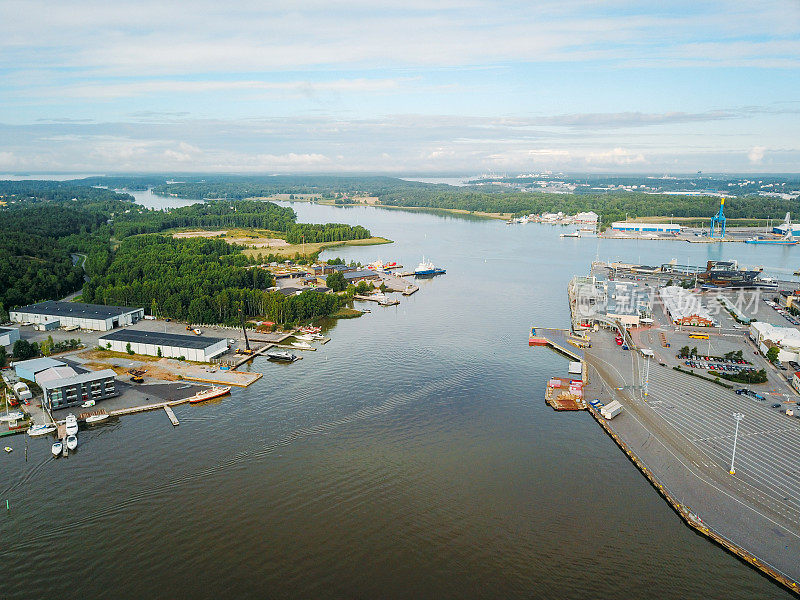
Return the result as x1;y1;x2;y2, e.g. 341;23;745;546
114;176;796;225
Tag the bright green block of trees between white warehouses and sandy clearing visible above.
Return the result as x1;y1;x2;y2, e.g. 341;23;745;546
84;235;339;324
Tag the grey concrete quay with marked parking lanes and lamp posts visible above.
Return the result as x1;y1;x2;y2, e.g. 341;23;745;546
585;332;800;592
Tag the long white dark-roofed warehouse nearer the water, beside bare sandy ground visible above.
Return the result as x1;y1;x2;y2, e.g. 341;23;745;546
97;329;228;362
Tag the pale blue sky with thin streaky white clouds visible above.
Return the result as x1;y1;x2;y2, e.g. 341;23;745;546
0;0;800;174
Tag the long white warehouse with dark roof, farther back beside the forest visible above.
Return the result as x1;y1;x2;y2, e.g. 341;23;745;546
9;300;144;331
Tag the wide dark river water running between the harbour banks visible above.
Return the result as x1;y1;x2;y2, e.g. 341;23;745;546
0;195;800;599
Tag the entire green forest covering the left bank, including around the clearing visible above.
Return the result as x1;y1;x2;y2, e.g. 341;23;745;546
0;181;358;323
